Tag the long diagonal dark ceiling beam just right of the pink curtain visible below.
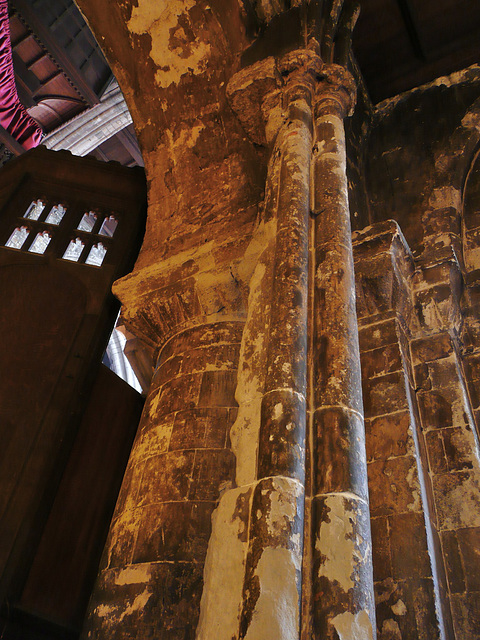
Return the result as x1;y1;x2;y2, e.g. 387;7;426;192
15;0;100;106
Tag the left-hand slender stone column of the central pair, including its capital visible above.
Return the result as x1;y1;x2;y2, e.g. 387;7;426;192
239;50;321;640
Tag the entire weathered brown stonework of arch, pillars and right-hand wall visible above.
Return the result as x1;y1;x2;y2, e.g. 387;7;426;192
70;0;480;640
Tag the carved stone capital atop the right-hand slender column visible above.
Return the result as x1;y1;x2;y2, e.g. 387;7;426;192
314;64;357;119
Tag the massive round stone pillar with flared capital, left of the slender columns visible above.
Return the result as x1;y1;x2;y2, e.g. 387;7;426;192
84;258;243;640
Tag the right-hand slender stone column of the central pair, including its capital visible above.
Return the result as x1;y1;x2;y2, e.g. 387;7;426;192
310;64;375;640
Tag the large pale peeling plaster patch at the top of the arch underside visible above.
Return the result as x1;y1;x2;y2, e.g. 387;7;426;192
128;0;211;88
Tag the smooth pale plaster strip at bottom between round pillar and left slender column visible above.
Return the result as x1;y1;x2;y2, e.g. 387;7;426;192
195;488;248;640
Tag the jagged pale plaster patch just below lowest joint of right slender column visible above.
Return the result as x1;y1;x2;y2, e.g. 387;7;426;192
315;495;362;592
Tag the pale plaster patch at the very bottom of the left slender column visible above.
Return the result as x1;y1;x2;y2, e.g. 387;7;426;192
244;548;301;640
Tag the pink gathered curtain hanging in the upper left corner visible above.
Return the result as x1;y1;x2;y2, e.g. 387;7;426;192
0;0;43;149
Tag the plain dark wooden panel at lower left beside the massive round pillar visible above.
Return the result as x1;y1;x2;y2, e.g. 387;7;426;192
21;366;143;627
